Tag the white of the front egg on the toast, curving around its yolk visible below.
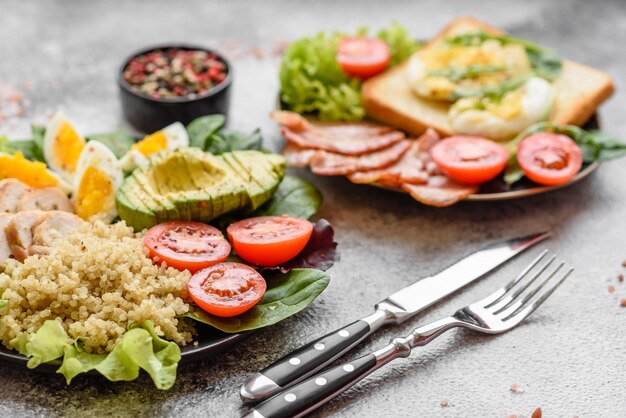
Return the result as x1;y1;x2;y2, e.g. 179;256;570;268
448;77;555;140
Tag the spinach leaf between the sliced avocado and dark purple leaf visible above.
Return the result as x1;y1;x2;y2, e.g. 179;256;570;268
250;176;323;219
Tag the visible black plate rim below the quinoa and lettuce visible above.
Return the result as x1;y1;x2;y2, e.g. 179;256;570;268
0;322;253;375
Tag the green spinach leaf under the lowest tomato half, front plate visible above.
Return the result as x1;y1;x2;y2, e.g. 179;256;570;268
185;269;330;333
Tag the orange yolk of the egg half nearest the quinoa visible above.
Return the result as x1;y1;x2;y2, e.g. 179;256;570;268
76;167;114;220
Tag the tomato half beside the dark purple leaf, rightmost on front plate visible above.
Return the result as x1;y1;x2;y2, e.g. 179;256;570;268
227;216;313;266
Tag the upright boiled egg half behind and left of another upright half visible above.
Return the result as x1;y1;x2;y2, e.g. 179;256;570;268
43;112;85;181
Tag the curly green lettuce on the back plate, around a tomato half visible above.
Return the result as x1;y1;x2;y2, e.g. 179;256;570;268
280;23;419;121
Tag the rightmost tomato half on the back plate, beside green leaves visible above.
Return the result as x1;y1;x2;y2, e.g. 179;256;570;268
517;132;583;186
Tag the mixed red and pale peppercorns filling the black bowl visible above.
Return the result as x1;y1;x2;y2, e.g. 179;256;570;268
124;48;226;99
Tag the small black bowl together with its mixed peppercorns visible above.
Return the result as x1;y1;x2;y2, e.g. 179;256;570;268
117;45;233;132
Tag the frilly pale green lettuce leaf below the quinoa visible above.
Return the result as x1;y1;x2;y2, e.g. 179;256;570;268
11;320;181;389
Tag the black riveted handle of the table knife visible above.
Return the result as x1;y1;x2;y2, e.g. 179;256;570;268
261;319;370;390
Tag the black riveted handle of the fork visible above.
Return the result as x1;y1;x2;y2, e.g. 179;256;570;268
247;354;377;418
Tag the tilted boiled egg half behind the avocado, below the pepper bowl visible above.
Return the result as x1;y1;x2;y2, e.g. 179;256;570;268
120;122;189;171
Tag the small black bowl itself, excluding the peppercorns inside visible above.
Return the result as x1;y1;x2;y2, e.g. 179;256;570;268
117;44;233;133
